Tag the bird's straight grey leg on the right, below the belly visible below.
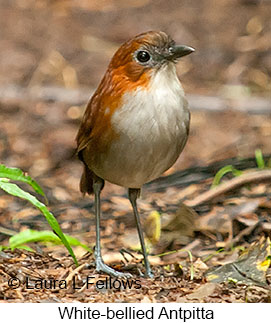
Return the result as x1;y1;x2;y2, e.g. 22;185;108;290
128;188;153;278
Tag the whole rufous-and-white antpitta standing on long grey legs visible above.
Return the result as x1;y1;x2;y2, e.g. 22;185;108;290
76;31;194;278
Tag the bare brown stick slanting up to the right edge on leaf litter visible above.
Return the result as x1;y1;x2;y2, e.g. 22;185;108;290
185;170;271;207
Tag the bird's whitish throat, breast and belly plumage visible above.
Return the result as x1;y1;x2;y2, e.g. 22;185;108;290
95;65;189;188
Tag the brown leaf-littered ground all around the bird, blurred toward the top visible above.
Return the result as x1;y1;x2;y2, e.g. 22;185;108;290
0;0;271;302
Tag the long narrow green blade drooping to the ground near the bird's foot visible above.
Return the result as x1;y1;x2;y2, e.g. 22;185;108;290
0;181;78;266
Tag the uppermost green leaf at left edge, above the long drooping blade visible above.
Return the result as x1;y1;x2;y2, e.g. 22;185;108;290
0;164;47;203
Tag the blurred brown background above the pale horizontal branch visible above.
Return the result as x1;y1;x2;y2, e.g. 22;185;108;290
0;0;271;95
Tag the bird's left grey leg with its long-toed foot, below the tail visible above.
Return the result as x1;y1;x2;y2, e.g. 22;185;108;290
93;177;132;278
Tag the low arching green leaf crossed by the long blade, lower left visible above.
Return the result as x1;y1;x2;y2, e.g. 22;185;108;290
9;229;91;252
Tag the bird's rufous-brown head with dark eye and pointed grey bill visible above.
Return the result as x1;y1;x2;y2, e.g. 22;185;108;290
109;31;194;82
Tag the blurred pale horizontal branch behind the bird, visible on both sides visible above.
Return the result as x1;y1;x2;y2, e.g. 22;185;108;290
0;84;271;115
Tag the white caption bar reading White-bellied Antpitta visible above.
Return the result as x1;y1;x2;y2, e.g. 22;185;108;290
0;303;271;323
